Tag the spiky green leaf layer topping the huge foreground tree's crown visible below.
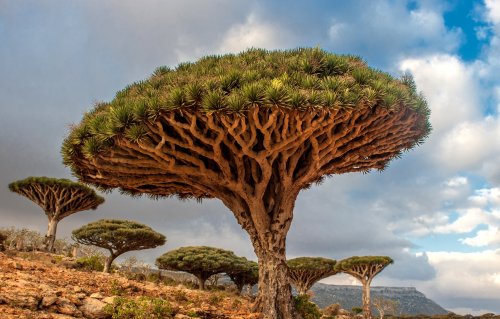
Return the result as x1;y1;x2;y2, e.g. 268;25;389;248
62;48;430;166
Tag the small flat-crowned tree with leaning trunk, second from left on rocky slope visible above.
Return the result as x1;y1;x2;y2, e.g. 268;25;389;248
72;219;166;272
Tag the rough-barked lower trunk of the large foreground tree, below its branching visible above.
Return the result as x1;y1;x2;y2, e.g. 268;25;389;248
254;247;295;319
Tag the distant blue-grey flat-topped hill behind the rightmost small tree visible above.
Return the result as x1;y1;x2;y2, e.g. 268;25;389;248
311;283;448;315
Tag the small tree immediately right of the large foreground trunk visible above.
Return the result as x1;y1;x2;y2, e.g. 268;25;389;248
287;257;337;295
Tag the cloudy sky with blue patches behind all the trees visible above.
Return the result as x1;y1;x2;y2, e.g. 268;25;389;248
0;0;500;314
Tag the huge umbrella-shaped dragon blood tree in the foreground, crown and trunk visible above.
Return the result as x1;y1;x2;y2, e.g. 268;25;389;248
62;48;430;318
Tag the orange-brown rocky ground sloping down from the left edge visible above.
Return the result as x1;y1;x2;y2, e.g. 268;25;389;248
0;253;257;319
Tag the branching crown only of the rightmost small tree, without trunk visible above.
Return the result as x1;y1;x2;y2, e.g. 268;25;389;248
335;256;394;282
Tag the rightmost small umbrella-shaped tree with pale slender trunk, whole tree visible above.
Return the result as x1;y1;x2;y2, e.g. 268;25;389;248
335;256;394;318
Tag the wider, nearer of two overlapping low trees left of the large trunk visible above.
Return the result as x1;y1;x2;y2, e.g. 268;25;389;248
156;246;245;290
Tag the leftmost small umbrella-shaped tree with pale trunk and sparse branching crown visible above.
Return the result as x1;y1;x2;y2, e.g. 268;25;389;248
9;177;104;252
